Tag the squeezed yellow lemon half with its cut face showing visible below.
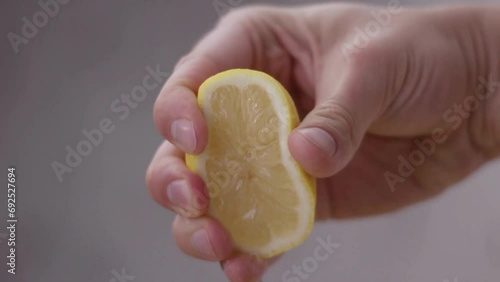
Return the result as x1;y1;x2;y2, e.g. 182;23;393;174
186;69;316;258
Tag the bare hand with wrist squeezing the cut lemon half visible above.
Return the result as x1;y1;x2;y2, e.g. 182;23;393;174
147;4;500;281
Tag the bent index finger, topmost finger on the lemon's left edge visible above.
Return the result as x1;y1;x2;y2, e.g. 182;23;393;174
154;9;262;154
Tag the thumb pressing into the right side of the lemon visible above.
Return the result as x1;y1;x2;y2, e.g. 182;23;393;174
288;53;388;178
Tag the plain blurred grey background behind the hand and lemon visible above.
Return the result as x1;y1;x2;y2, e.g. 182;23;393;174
0;0;500;282
